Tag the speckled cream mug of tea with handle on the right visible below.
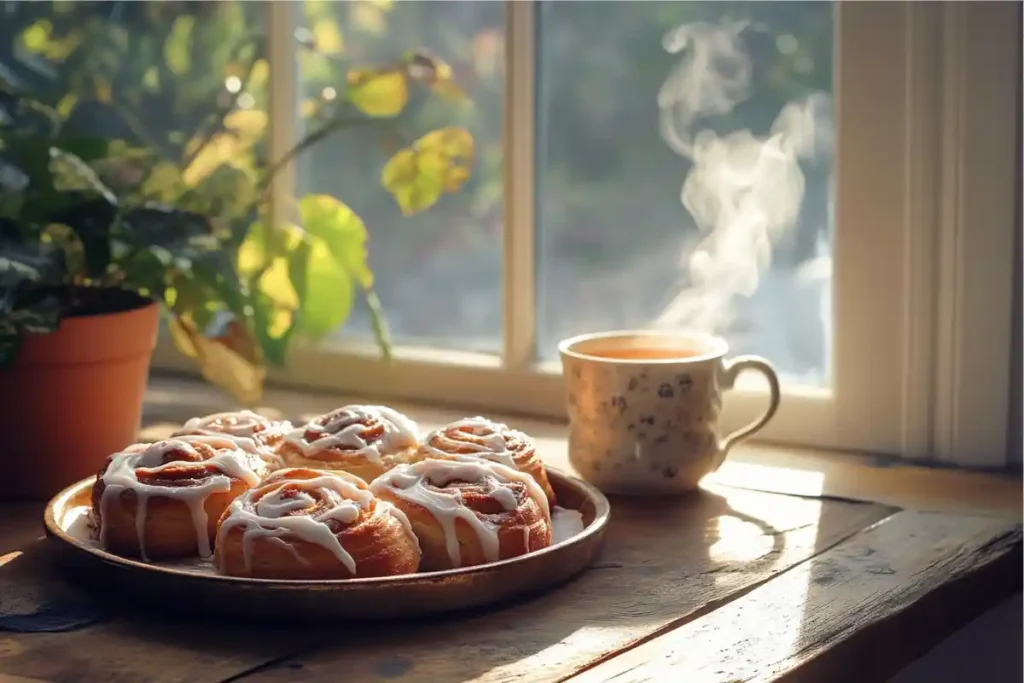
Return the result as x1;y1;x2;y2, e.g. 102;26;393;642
558;331;779;495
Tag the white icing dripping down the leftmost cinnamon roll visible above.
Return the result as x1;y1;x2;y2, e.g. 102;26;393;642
99;435;259;560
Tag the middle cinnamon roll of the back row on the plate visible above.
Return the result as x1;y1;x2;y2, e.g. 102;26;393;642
280;405;418;482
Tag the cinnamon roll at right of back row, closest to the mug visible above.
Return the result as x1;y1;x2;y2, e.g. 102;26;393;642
413;417;555;506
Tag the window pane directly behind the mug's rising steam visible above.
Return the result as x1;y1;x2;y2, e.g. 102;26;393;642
537;1;833;385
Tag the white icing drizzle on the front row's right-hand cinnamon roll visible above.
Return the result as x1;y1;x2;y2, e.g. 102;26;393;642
370;460;551;567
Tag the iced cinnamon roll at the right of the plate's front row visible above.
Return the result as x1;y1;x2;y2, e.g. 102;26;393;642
370;460;551;570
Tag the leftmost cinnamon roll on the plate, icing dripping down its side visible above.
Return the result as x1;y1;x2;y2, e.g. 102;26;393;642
92;435;266;560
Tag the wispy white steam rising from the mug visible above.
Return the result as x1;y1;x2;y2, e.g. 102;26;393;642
654;20;833;332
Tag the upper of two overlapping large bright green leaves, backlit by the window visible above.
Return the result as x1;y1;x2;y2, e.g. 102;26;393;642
299;195;374;289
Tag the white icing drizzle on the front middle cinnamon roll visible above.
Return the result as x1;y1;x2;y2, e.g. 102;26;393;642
217;473;416;575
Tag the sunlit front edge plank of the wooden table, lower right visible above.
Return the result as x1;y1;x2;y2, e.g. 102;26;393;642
571;512;1022;683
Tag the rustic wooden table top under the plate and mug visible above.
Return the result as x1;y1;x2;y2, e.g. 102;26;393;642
0;382;1022;683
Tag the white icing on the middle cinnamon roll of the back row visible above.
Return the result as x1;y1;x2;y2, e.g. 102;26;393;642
285;405;419;465
